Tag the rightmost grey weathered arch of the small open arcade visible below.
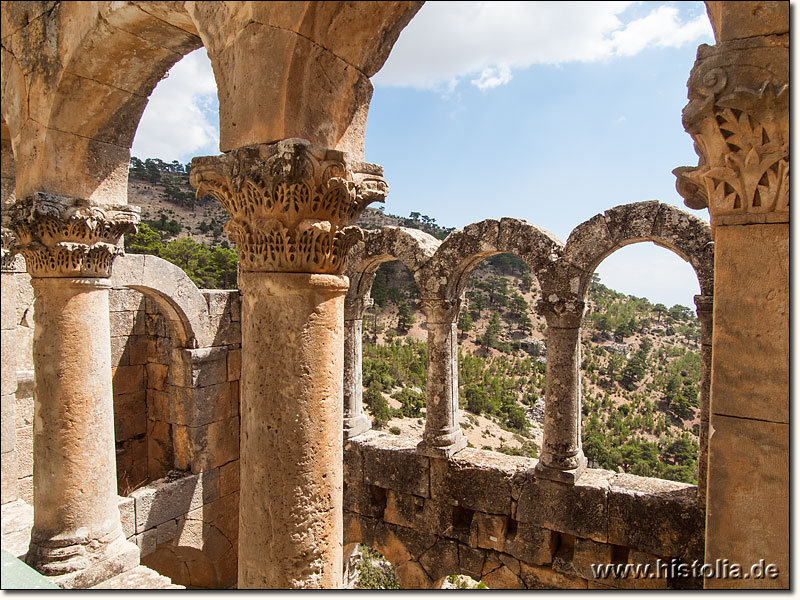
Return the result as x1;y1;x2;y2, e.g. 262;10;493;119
563;200;714;299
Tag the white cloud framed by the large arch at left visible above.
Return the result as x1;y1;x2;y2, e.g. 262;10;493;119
131;48;219;162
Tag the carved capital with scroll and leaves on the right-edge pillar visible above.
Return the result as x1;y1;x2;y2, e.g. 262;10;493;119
673;35;789;225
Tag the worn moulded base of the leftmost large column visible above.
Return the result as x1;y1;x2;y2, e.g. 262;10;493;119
25;532;140;589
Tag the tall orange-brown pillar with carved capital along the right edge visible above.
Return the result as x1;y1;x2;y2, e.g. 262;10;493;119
674;2;790;588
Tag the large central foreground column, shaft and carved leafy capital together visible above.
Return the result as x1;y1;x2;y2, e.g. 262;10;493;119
191;139;387;588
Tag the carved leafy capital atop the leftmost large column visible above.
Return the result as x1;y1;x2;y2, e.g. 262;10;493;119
9;192;139;277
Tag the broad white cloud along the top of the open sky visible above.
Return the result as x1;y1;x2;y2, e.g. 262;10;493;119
373;2;712;91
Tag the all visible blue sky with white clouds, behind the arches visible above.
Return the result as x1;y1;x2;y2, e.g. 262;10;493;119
132;2;713;306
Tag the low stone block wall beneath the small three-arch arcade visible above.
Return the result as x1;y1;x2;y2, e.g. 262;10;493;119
344;432;704;589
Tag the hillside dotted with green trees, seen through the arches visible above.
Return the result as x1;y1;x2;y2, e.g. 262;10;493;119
125;158;700;483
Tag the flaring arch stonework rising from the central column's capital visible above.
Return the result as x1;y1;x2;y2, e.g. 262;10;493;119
187;1;422;160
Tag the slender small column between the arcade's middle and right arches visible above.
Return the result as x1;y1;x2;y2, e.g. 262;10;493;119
536;300;586;483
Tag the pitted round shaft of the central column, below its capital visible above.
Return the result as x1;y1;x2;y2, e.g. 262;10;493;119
239;272;347;588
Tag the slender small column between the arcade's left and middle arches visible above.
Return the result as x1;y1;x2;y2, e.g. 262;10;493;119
418;298;467;457
